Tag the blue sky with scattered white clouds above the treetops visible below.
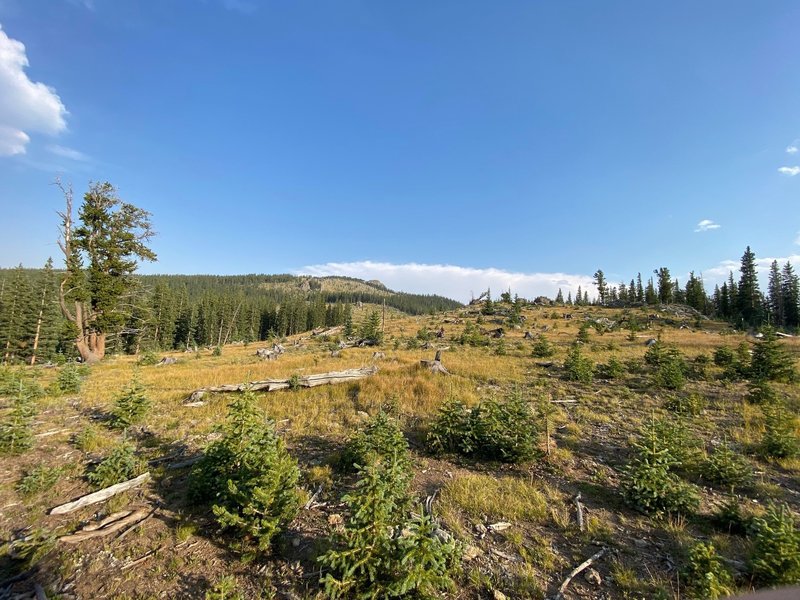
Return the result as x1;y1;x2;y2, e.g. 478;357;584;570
0;0;800;299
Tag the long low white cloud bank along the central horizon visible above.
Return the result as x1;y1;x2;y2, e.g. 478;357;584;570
297;260;595;302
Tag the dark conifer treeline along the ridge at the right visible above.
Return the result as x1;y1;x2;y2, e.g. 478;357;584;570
572;246;800;331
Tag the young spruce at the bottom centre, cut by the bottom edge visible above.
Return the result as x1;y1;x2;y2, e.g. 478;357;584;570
318;455;460;599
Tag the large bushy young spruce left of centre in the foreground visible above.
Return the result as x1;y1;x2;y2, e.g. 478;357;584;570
190;392;300;551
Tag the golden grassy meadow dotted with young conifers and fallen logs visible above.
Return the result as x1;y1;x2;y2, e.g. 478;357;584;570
0;307;800;599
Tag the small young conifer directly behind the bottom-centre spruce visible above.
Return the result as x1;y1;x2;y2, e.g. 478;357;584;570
341;410;410;471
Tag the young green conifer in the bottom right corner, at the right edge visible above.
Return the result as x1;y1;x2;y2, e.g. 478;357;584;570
750;504;800;585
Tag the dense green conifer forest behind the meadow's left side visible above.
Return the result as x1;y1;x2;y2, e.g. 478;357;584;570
0;268;460;364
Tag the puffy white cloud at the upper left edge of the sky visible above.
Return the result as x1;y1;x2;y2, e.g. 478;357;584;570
0;26;67;156
